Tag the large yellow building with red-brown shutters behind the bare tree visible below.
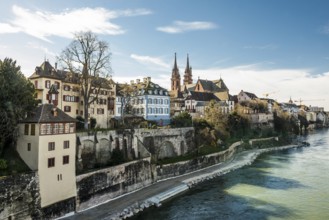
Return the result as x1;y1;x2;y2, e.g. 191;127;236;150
29;61;116;128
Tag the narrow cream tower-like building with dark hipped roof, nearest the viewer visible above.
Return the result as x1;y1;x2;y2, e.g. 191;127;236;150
17;104;76;207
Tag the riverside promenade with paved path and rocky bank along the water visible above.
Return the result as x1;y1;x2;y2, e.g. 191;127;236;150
63;145;297;220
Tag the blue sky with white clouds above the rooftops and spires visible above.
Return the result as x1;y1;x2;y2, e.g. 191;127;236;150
0;0;329;111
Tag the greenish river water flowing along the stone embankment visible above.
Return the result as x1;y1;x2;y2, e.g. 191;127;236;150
133;130;329;220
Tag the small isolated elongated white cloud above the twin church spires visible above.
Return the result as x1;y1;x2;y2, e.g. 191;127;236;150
157;21;217;34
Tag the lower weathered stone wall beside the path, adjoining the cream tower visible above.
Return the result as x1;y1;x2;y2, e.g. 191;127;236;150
77;157;152;210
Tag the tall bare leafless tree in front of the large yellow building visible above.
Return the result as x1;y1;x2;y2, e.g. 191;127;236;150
57;32;111;129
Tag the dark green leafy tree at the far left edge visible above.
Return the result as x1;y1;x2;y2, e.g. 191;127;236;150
0;58;36;155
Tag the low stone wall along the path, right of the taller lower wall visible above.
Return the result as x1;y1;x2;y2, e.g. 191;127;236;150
155;141;243;181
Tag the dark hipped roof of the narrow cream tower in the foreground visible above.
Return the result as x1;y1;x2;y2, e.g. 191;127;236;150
21;104;76;123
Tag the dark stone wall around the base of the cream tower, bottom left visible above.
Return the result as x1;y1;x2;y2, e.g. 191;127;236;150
0;172;75;219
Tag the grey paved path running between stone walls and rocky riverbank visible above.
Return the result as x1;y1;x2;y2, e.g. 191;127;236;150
65;150;256;220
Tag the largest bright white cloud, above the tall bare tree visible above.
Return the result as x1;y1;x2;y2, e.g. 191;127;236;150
0;5;151;42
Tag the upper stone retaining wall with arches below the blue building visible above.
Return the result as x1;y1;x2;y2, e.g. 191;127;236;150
77;128;195;172
